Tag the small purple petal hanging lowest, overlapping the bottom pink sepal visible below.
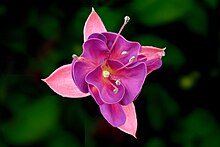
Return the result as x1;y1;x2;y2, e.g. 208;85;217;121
99;104;126;127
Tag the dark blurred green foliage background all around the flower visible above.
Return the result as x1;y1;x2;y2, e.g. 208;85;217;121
0;0;220;147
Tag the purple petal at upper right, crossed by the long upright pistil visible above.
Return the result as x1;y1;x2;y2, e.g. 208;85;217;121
102;32;141;64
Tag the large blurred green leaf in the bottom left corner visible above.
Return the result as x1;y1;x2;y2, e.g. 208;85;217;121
2;96;59;145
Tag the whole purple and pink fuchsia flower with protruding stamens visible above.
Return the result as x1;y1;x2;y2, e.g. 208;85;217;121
43;9;164;137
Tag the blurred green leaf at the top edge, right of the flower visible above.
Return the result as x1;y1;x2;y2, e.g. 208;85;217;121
131;0;193;26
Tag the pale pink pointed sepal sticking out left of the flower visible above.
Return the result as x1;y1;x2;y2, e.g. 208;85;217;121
42;64;89;98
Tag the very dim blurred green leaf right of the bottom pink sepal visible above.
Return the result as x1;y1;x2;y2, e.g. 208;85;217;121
144;84;179;130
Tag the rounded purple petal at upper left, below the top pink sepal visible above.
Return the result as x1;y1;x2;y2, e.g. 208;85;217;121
82;38;109;65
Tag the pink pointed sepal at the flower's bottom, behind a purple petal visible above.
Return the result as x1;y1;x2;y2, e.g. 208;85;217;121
118;103;137;138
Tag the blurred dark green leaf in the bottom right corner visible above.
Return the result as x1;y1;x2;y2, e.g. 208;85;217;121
173;108;220;147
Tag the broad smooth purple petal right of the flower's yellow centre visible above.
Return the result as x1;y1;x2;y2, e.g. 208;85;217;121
117;62;147;105
